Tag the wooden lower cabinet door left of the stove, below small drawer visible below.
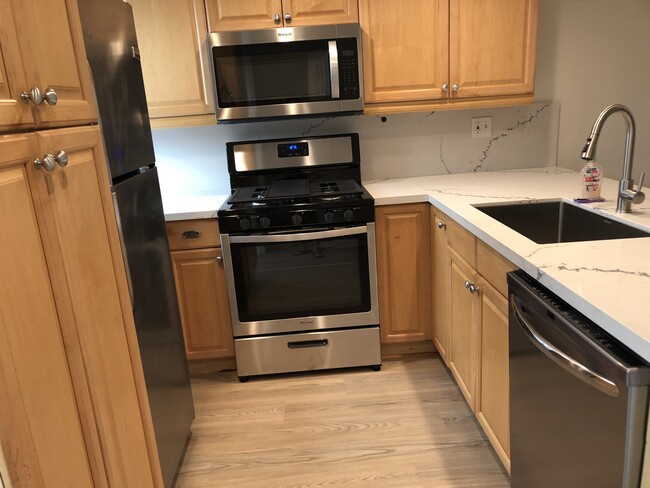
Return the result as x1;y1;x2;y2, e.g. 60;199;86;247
172;248;234;359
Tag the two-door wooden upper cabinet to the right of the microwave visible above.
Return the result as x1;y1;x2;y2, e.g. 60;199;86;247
359;0;538;113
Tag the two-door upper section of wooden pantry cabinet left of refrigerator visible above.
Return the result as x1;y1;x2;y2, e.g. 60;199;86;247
0;0;97;132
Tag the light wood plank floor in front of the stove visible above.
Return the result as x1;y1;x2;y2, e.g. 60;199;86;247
176;357;510;488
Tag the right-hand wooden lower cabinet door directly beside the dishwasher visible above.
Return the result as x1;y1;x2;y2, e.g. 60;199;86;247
476;277;510;472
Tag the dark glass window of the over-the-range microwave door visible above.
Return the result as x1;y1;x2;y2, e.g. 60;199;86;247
212;40;332;108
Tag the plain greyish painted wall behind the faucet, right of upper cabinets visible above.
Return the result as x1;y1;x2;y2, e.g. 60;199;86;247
535;0;650;180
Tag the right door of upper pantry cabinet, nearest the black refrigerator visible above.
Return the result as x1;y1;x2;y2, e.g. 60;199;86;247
2;0;97;127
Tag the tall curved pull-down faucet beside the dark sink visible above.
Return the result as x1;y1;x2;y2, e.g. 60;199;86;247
580;104;645;212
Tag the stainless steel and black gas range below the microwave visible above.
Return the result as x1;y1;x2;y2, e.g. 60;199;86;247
218;134;381;381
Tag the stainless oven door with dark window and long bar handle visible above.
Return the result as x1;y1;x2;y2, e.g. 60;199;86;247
221;223;379;337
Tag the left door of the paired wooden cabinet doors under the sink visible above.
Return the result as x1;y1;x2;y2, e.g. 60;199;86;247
448;248;479;411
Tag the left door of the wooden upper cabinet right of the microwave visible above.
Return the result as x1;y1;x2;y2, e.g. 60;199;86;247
359;0;449;102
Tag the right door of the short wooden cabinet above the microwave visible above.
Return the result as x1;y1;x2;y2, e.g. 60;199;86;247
282;0;359;27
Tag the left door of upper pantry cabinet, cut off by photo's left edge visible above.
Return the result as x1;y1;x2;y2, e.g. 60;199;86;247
0;0;34;131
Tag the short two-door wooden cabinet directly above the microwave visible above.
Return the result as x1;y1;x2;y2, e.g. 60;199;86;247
206;0;359;32
